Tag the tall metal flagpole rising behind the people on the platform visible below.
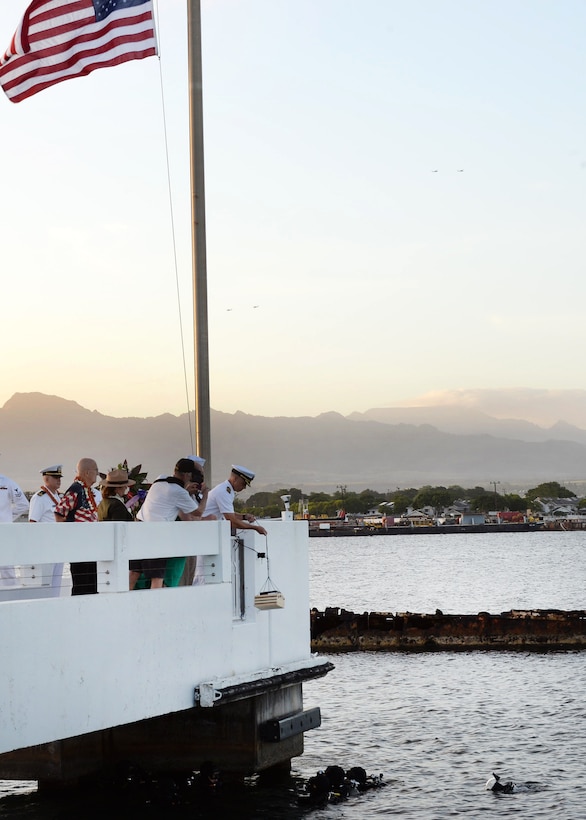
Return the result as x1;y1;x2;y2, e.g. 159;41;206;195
187;0;212;485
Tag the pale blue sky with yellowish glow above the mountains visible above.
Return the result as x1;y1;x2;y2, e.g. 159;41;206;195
0;0;586;416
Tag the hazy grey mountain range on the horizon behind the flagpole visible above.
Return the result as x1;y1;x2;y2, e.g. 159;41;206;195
0;393;586;492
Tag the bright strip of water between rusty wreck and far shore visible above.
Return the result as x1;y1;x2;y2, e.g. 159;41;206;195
311;532;586;612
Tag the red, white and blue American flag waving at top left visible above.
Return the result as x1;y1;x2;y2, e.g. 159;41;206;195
0;0;157;102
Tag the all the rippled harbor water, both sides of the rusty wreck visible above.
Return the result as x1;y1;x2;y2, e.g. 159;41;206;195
0;533;586;820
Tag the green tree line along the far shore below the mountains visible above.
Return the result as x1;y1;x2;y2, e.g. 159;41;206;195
235;481;586;518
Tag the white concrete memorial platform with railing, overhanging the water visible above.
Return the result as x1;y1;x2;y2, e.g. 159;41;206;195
0;521;331;778
